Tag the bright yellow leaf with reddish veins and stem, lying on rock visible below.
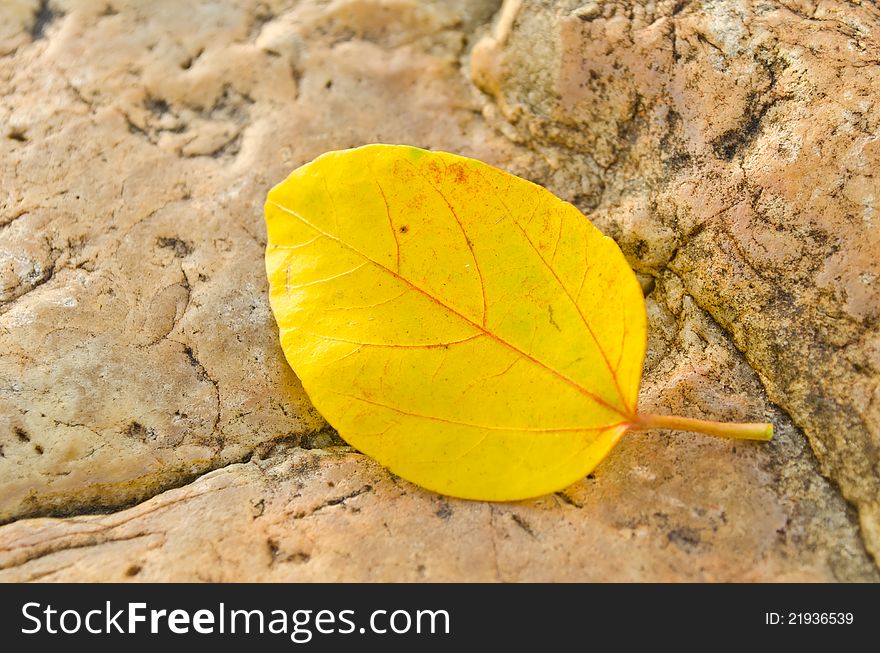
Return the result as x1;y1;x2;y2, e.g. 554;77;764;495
266;145;768;500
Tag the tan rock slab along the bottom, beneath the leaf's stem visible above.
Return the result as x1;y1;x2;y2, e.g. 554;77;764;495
0;273;880;581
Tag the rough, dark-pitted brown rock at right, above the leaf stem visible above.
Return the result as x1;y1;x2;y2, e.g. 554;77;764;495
472;0;880;556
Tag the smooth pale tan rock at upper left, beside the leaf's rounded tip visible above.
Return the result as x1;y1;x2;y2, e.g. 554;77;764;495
0;0;511;520
